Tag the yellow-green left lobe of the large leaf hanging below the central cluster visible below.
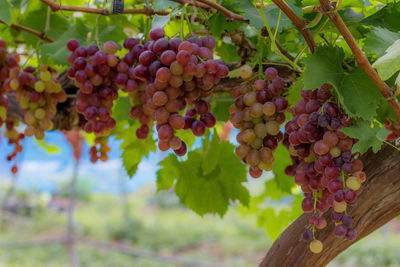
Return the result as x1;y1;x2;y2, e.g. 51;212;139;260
157;154;179;191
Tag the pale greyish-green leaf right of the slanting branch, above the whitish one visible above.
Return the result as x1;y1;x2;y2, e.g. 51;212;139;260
363;27;400;56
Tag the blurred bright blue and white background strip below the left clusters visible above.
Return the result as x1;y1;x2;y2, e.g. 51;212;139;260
0;131;165;193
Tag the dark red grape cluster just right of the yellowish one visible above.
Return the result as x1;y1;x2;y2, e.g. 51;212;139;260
67;39;121;136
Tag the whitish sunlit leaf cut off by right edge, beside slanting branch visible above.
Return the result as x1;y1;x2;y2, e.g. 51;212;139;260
372;39;400;80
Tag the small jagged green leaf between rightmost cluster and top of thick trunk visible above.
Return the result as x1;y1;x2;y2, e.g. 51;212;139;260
342;120;389;154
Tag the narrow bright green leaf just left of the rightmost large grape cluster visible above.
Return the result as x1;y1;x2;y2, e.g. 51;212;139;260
273;143;295;193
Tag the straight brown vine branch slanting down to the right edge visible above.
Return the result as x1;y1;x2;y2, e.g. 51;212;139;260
318;0;400;120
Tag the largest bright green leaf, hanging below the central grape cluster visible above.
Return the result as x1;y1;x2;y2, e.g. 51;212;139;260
157;142;249;217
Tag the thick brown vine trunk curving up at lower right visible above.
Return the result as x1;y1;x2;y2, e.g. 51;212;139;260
260;145;400;267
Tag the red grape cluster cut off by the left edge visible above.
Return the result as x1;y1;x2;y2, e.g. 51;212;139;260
0;39;19;127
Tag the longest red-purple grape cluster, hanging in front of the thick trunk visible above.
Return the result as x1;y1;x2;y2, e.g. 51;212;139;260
283;84;366;253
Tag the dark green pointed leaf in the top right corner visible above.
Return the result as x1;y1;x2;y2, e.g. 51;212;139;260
361;2;400;32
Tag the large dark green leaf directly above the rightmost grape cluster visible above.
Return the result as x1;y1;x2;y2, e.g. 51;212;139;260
304;46;382;120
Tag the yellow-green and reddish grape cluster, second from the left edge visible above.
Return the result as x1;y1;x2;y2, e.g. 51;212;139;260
10;65;67;139
